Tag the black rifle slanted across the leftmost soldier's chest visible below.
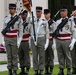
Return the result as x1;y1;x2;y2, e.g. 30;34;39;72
1;10;23;35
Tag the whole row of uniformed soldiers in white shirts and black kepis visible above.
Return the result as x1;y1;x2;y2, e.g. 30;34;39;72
1;3;76;75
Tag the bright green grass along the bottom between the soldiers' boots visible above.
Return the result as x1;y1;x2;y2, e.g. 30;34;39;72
0;65;72;75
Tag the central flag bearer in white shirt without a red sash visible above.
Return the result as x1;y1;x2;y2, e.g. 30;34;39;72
30;7;49;75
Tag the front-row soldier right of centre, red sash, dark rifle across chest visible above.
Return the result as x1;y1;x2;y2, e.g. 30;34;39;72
53;5;75;75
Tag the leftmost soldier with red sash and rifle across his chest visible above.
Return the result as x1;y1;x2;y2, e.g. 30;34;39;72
3;3;23;75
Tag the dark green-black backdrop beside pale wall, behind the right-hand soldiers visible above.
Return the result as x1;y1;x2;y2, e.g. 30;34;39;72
48;0;74;19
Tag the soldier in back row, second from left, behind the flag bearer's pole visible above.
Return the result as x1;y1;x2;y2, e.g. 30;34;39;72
18;10;30;75
